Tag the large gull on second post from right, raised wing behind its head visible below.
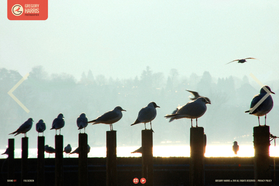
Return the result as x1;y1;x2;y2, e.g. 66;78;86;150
165;97;211;127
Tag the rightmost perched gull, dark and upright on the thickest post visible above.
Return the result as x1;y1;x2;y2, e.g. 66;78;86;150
245;86;275;126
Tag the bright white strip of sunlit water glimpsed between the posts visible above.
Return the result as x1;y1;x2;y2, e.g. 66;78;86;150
0;145;280;158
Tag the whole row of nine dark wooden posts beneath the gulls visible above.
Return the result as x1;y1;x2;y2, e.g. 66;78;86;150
4;126;270;186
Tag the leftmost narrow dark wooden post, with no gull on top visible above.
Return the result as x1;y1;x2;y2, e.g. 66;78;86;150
7;138;16;185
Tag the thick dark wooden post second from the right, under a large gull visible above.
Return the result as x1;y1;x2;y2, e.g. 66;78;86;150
190;127;206;186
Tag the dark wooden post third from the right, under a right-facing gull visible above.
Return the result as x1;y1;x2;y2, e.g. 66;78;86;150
142;130;154;186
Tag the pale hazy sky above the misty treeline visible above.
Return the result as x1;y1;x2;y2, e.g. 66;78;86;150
0;0;279;82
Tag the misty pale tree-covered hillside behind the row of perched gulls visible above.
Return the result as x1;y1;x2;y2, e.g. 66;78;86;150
0;66;279;158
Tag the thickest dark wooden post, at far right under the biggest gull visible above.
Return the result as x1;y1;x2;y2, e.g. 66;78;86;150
254;126;271;186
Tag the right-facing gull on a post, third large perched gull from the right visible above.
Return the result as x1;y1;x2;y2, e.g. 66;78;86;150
131;102;160;130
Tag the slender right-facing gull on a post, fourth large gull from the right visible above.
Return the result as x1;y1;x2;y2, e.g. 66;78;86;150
88;106;126;131
